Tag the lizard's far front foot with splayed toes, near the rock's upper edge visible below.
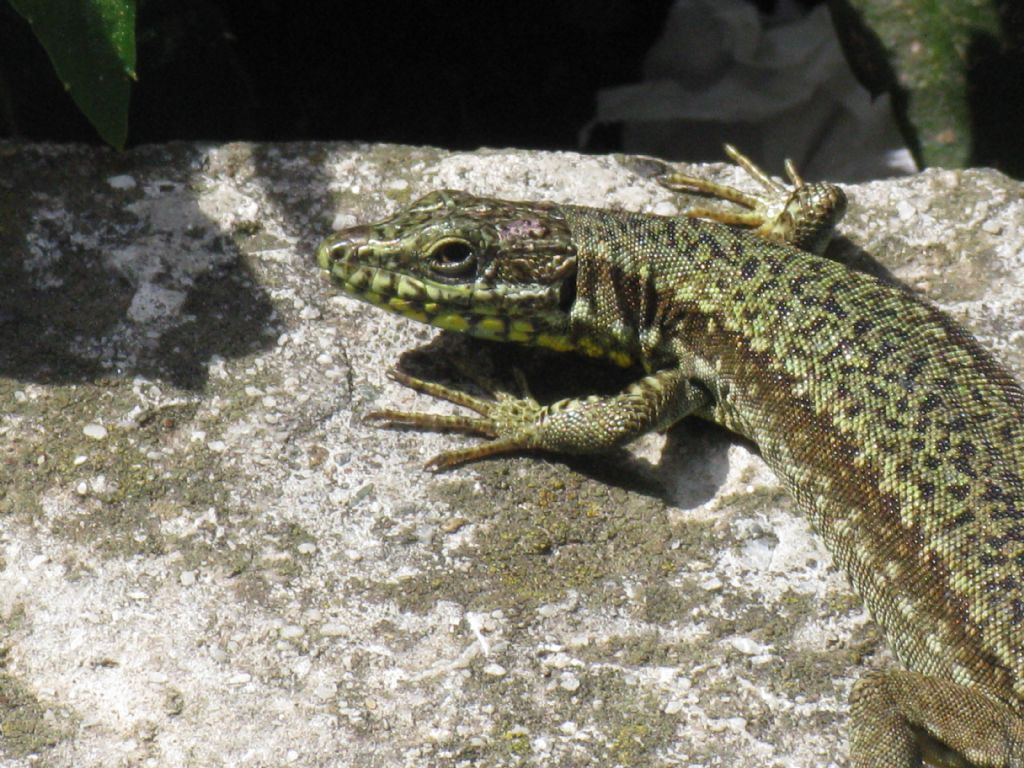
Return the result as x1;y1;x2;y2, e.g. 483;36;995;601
657;144;846;255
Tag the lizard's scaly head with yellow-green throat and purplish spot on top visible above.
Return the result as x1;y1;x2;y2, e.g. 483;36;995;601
316;189;577;351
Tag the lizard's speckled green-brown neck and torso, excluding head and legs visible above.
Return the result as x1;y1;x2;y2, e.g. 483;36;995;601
562;207;1024;709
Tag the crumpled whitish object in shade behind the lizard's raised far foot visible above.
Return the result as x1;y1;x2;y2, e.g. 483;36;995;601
595;0;915;181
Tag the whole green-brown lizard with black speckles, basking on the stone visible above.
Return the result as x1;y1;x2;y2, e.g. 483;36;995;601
317;147;1024;768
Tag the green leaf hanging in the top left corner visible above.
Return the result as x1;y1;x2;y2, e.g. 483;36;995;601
10;0;135;150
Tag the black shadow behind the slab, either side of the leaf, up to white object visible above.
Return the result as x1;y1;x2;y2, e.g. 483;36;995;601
0;0;794;152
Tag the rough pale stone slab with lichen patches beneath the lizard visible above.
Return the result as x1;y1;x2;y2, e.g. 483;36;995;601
0;143;1024;767
